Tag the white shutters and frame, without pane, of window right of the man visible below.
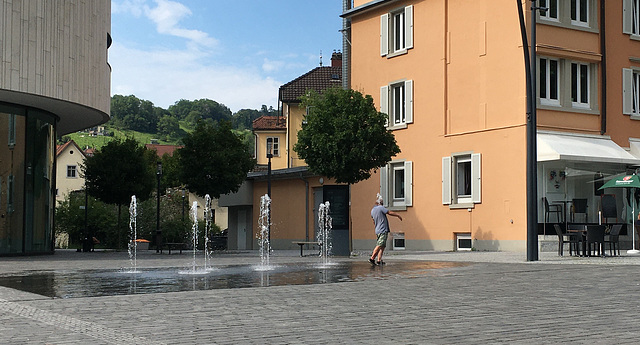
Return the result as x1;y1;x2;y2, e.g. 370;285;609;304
442;152;482;208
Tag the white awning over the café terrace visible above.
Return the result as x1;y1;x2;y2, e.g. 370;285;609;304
537;131;640;165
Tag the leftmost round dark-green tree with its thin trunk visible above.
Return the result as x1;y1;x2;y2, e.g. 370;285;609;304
81;138;157;246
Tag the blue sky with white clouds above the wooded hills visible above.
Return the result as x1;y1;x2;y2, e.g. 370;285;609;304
109;0;342;112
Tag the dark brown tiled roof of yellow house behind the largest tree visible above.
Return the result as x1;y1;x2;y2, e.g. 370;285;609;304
280;66;342;102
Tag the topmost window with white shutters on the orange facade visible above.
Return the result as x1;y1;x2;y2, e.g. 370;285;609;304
380;5;413;57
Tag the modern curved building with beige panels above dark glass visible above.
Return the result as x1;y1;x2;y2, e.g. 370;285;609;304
0;0;111;255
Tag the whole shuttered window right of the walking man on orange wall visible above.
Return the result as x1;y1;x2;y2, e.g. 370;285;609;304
442;153;482;207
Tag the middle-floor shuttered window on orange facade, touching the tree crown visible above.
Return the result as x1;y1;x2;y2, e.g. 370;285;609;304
380;80;413;129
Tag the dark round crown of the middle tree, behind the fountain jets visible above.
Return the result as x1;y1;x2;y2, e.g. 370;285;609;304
177;121;255;198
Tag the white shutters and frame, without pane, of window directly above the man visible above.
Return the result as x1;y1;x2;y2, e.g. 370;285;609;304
380;160;413;210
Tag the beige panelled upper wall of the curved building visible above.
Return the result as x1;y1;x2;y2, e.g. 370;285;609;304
0;0;111;114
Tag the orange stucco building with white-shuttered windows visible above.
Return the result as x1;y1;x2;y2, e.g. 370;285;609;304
342;0;640;251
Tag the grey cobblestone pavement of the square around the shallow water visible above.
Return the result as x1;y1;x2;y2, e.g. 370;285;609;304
0;250;640;344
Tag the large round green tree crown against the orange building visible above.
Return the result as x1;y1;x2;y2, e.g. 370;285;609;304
293;88;400;184
